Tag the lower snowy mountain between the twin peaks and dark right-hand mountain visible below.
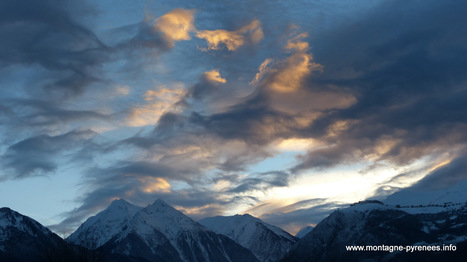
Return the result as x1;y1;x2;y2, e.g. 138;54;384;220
200;214;296;261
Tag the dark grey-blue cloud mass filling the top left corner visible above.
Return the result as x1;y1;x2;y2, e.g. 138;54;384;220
0;1;106;96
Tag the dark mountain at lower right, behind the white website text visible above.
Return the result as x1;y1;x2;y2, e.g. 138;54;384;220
281;201;467;261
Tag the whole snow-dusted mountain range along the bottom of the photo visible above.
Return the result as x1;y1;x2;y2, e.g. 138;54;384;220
0;180;467;262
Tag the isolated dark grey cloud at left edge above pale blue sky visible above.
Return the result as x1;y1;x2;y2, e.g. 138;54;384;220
2;130;96;179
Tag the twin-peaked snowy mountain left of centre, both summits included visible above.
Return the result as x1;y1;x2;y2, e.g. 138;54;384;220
67;200;257;261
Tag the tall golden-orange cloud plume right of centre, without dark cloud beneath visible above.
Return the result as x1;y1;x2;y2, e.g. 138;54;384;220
254;30;356;119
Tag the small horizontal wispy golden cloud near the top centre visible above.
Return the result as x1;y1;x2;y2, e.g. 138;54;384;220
196;20;264;51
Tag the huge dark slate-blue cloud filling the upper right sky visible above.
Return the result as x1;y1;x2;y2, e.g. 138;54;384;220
293;1;467;172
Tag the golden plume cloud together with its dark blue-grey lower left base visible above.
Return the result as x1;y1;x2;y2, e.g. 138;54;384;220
186;28;356;146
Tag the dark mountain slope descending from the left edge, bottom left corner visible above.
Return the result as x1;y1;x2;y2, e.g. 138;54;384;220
0;208;98;262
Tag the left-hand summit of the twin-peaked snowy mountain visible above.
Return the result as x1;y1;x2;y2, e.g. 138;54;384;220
67;199;142;249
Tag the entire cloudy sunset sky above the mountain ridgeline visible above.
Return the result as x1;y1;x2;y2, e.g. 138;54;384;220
0;0;467;236
